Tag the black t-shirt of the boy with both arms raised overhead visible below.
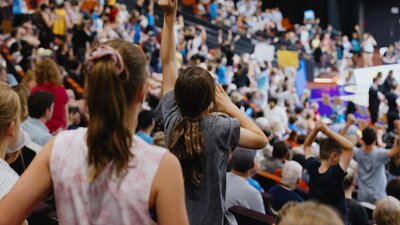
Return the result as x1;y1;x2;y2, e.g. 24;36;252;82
305;157;347;221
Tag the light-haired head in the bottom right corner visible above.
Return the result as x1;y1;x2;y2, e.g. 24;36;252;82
372;196;400;225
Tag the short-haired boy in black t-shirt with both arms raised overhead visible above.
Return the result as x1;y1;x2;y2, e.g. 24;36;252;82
304;121;353;221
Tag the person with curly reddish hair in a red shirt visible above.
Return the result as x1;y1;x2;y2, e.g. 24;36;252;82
32;58;69;133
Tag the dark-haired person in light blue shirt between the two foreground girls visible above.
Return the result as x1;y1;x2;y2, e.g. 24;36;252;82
136;110;155;144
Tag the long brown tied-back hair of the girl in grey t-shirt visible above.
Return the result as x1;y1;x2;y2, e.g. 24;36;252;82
168;67;215;187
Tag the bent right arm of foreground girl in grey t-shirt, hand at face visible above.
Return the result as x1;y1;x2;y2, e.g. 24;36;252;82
213;84;268;150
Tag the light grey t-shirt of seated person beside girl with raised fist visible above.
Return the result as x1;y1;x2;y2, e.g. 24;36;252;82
226;173;265;214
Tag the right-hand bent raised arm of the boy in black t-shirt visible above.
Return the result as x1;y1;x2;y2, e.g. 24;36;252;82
316;121;353;171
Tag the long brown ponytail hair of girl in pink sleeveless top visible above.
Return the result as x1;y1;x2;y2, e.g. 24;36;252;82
87;40;147;181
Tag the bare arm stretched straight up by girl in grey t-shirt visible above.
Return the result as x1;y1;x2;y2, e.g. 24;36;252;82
158;0;178;95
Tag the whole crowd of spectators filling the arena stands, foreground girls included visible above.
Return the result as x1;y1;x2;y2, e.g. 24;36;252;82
0;0;400;225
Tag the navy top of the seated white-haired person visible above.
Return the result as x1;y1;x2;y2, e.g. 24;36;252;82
268;185;304;211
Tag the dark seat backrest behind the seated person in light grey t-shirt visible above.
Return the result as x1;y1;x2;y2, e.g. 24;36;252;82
229;206;276;225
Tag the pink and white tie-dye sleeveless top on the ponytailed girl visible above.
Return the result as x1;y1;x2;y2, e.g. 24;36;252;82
50;128;167;225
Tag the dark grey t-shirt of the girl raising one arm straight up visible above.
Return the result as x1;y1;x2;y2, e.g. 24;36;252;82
154;91;240;225
